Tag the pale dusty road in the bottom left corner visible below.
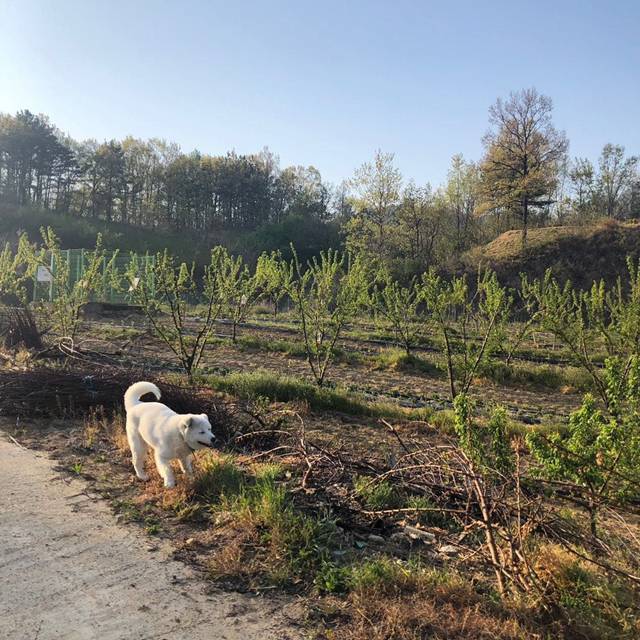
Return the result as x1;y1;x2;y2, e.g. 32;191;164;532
0;432;299;640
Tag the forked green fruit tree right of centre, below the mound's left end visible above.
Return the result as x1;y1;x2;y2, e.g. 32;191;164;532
422;269;512;400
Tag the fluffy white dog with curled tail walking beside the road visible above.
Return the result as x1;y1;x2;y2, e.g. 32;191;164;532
124;382;215;487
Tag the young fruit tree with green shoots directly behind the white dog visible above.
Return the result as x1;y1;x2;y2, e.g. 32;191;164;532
127;247;227;380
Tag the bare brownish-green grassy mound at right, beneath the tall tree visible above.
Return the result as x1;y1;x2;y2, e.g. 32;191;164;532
462;220;640;287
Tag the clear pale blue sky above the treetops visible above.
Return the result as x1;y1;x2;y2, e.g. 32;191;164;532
0;0;640;184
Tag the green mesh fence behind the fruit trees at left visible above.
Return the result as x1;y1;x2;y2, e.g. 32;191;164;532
33;249;155;304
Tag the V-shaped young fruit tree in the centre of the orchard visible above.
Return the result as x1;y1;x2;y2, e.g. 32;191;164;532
280;245;368;387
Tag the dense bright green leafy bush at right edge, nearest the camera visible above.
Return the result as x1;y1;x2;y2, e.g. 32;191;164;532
527;356;640;537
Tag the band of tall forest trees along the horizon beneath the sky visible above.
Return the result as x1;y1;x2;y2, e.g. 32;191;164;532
0;89;640;277
